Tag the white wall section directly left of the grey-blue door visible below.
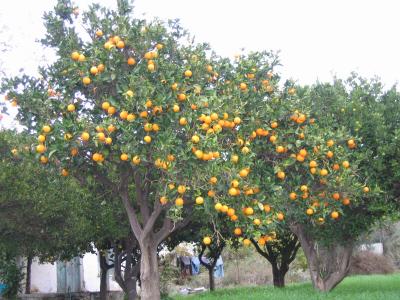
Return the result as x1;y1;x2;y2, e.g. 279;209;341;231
31;258;57;293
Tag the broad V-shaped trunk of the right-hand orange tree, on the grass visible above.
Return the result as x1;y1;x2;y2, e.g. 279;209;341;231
291;224;353;292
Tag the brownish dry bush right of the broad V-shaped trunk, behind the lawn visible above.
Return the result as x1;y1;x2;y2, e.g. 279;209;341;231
350;251;395;275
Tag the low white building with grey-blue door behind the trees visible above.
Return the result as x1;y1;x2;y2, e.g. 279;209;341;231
31;253;122;293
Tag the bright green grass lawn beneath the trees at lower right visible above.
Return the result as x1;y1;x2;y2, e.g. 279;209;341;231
172;273;400;300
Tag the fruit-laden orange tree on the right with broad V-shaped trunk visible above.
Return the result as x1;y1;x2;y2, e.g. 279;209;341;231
217;77;385;291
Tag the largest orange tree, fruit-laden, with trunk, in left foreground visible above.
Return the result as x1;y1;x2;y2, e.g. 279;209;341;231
2;0;284;299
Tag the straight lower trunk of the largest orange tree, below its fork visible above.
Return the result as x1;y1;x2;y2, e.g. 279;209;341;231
140;239;160;300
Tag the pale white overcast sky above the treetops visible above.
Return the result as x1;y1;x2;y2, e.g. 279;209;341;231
0;0;400;126
